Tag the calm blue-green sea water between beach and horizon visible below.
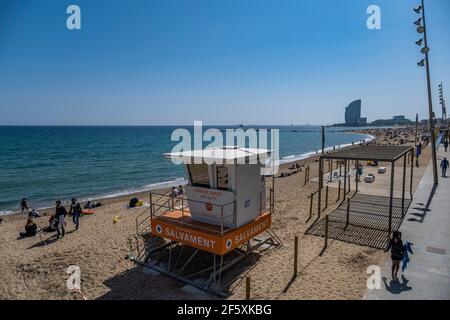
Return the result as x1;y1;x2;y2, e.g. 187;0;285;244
0;126;367;214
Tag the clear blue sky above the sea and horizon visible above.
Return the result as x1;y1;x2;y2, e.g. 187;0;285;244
0;0;450;125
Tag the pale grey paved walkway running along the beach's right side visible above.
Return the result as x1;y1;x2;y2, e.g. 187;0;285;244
364;149;450;300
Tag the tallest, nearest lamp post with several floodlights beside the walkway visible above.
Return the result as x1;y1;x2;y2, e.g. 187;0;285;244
414;0;439;185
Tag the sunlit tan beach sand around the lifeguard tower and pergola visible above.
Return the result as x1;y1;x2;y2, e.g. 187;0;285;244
0;128;430;299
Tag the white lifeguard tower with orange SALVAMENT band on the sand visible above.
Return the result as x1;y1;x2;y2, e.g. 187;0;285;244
131;147;281;294
